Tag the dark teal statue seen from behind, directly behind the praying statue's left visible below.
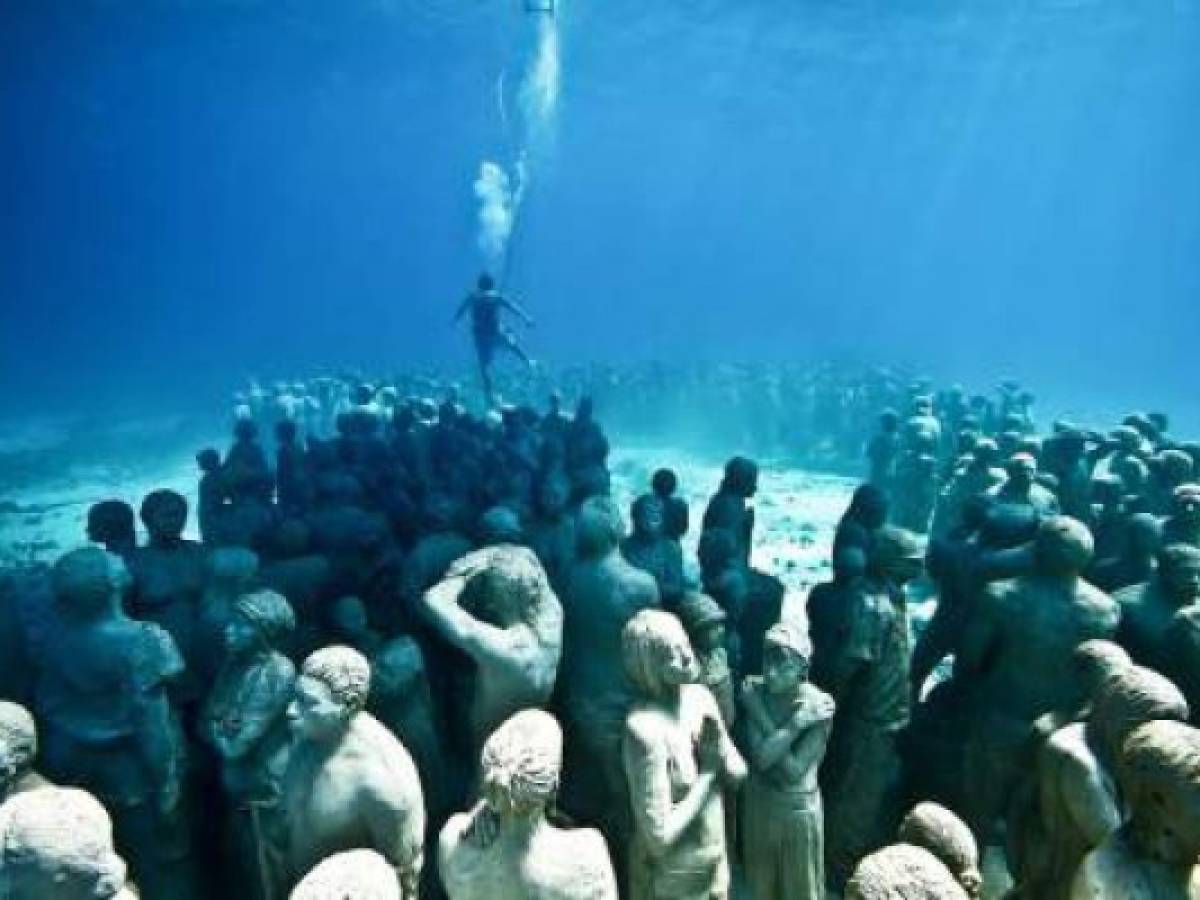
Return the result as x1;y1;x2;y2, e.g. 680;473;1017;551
558;497;659;871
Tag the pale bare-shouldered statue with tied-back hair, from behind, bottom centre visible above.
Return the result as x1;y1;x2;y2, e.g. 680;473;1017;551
438;709;617;900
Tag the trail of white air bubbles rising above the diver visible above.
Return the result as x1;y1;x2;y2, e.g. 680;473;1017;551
474;0;562;282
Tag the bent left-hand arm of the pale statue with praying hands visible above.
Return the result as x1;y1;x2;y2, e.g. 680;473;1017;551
623;722;716;859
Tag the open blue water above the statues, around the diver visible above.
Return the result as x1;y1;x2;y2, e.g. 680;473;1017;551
0;0;1200;426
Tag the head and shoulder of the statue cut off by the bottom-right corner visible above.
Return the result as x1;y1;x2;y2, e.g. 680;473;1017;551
1070;720;1200;900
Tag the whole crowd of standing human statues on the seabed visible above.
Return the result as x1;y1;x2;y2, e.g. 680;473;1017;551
0;367;1200;900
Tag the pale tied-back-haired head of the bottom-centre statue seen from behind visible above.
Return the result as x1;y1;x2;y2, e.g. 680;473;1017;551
481;709;563;816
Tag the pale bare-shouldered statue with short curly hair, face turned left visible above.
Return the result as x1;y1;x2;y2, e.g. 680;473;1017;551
282;647;425;900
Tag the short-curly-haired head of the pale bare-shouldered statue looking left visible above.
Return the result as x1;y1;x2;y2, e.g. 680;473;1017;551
288;647;371;743
